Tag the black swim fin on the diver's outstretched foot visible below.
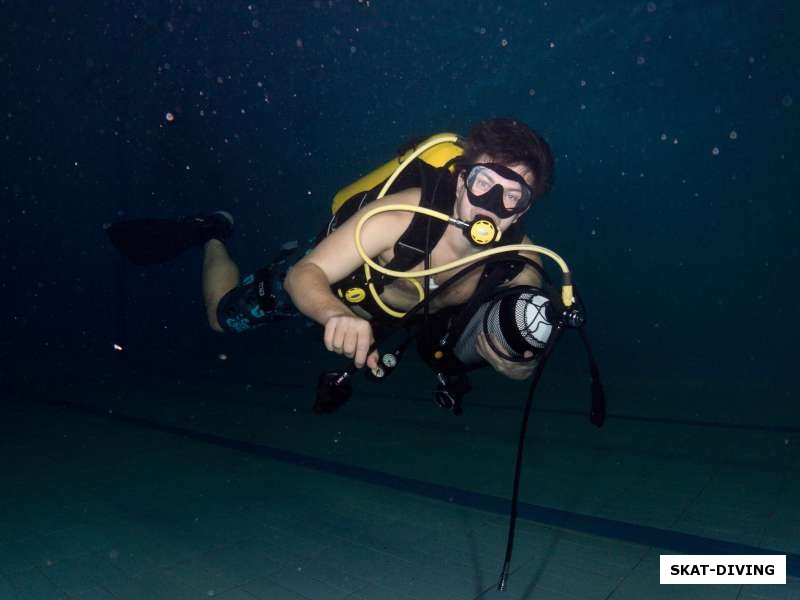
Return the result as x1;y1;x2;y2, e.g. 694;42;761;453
105;212;233;265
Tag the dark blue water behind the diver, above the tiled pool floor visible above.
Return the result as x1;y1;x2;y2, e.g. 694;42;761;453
0;0;800;425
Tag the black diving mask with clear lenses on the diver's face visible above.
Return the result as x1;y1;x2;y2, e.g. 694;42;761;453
464;163;533;219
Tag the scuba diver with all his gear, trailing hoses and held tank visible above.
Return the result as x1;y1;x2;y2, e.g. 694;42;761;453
106;118;605;589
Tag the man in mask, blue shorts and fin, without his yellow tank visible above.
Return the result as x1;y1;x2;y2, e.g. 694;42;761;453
108;119;554;398
